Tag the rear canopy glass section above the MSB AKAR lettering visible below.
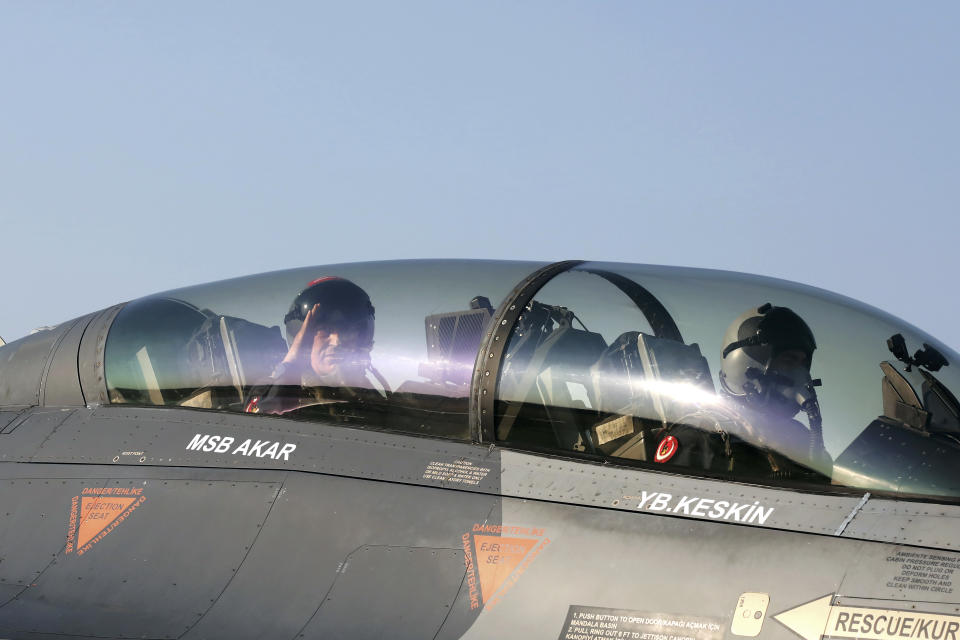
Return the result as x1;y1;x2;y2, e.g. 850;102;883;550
105;261;541;439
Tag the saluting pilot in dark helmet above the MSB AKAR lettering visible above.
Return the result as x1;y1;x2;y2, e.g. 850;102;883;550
245;276;389;414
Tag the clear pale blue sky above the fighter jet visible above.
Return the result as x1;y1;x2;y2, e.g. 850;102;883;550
0;0;960;348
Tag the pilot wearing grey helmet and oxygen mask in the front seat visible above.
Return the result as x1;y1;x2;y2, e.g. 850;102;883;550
654;303;830;479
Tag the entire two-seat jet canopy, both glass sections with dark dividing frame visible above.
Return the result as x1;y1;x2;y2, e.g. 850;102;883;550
88;261;960;499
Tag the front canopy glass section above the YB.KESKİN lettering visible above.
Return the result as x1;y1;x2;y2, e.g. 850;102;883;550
495;263;960;496
